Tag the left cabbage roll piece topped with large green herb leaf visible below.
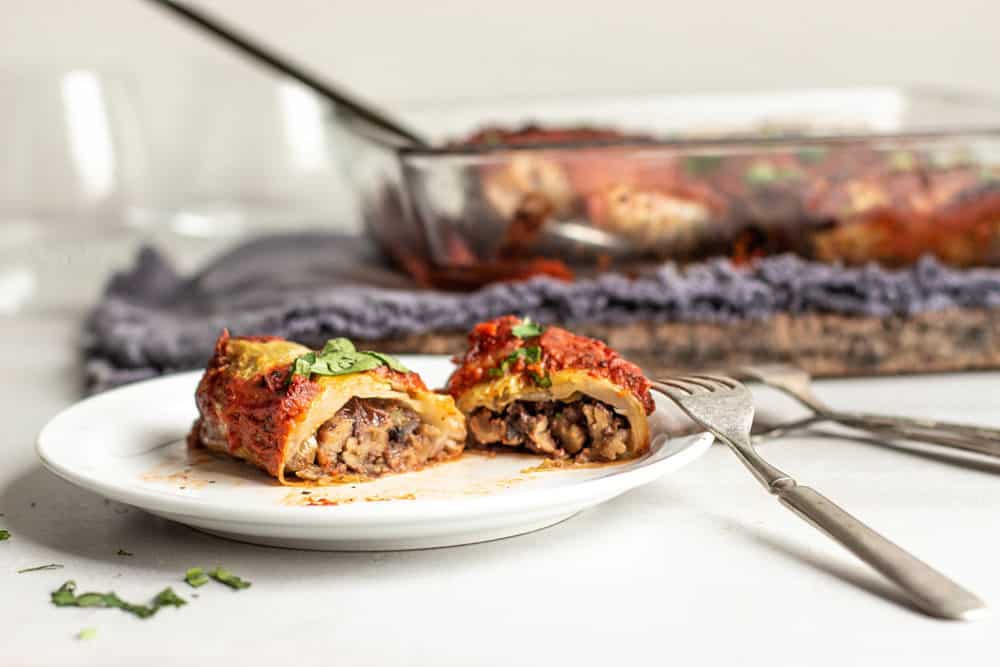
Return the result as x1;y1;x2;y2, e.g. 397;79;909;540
188;332;466;485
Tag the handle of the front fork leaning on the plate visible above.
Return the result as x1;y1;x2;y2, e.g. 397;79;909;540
771;479;986;620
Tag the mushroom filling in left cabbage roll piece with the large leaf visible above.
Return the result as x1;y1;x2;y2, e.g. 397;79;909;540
285;398;461;480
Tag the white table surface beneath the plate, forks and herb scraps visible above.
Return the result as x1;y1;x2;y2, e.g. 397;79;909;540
0;241;1000;667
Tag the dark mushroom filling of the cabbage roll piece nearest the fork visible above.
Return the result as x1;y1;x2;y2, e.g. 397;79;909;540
469;397;632;462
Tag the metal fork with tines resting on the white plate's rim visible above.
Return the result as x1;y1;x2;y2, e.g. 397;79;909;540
652;375;986;620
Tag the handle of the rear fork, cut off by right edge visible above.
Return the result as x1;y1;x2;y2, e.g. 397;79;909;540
826;412;1000;458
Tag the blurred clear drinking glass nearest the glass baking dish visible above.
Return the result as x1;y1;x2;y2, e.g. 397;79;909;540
170;68;357;237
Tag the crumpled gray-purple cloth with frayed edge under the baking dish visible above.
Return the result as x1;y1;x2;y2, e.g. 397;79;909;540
84;235;1000;391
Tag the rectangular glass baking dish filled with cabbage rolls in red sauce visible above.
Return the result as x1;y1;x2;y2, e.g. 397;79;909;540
335;88;1000;288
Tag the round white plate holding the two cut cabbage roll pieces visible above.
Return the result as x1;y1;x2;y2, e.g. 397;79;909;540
38;356;712;551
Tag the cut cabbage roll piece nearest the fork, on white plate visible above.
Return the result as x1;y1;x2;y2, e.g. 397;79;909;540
447;315;654;463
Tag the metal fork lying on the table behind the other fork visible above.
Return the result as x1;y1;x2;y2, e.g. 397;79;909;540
735;364;1000;457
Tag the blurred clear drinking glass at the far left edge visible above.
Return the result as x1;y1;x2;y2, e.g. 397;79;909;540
0;69;152;314
